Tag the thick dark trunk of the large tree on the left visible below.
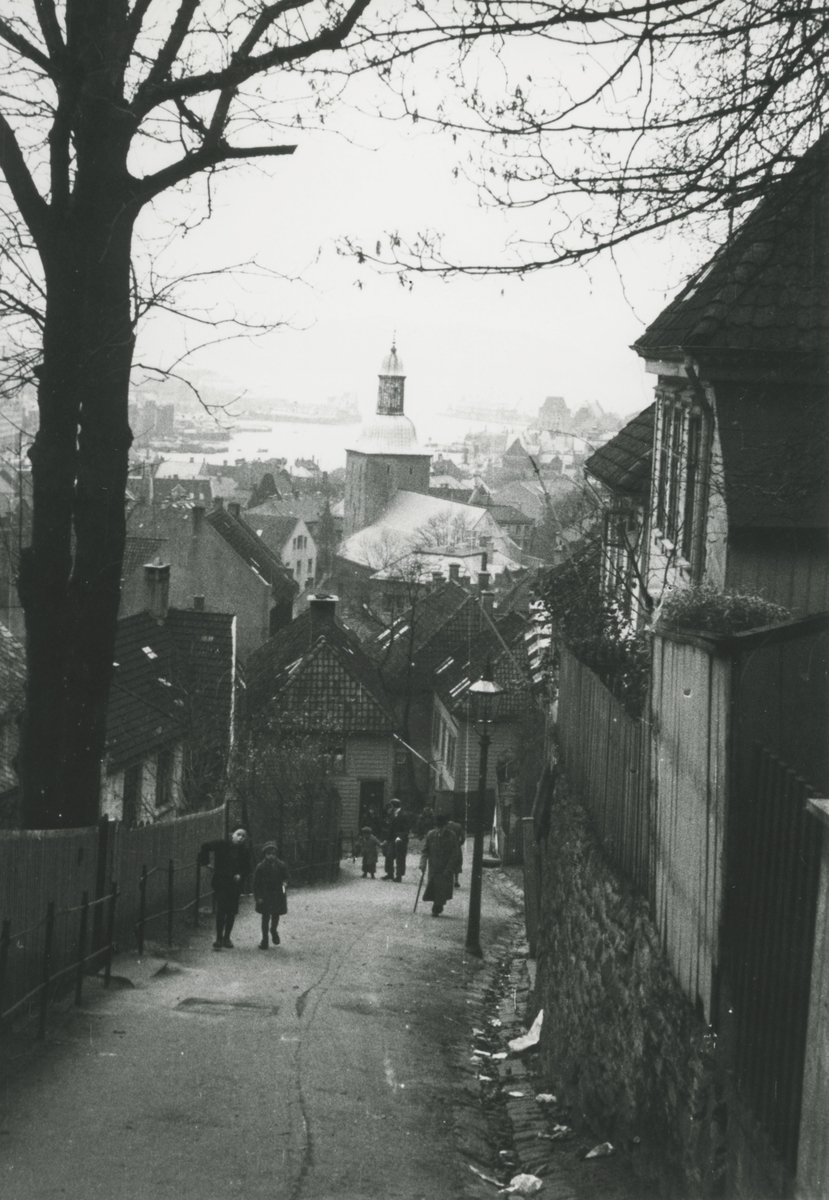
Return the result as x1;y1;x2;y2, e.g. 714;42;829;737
18;201;133;829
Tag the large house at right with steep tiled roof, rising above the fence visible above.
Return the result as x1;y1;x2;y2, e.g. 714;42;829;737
587;136;829;616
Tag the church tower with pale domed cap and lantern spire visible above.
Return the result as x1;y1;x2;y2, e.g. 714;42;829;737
343;342;431;538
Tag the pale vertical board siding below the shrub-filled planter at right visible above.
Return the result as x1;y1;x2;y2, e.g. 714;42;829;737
651;636;729;1022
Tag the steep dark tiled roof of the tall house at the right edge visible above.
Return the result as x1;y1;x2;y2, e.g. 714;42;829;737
633;133;829;359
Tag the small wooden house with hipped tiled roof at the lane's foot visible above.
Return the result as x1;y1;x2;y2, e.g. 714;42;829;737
247;595;397;836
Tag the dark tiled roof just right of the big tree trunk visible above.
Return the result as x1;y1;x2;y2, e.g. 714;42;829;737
107;608;233;770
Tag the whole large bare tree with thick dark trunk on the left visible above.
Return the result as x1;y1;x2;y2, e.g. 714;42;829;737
0;0;407;827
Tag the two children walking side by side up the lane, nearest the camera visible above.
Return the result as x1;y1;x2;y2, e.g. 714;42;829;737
200;826;288;950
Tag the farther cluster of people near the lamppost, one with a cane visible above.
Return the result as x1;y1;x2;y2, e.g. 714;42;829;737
360;800;463;917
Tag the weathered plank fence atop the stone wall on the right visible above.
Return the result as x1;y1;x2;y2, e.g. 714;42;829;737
558;648;651;896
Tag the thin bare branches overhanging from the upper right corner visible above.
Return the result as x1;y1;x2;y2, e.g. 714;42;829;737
349;0;829;274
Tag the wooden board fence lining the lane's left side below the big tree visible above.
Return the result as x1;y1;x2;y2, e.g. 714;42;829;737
0;809;224;1018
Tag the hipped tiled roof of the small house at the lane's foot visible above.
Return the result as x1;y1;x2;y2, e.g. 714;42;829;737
247;612;396;733
